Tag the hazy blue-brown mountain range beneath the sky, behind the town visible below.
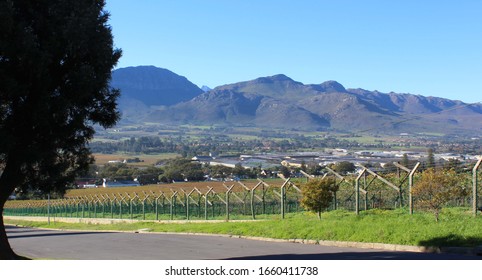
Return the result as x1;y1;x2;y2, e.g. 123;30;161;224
111;66;482;134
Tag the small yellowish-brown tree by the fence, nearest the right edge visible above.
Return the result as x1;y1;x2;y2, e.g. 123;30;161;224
412;168;464;222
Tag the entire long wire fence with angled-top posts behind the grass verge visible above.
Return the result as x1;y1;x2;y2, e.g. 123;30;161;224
4;160;482;220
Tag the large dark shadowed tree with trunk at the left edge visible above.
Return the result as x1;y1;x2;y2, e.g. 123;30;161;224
0;0;121;259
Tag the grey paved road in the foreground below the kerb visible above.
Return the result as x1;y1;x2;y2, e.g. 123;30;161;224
7;226;482;260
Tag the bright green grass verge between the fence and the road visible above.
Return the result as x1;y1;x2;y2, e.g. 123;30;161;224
7;208;482;247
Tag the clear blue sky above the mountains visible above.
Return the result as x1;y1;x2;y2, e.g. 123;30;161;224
106;0;482;102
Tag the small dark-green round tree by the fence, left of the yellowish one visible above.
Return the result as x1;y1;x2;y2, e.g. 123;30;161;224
300;178;338;219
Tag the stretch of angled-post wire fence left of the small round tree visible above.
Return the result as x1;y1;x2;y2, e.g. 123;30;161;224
4;180;302;220
